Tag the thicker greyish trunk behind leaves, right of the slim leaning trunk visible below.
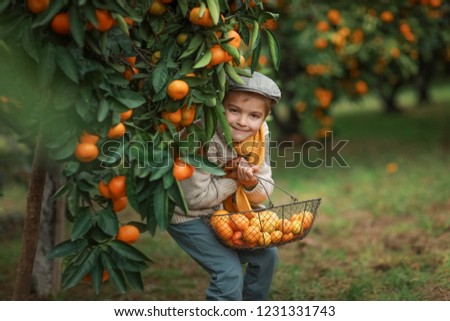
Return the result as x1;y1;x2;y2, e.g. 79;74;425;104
33;165;65;298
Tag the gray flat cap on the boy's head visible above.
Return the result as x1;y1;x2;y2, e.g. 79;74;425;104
229;71;281;103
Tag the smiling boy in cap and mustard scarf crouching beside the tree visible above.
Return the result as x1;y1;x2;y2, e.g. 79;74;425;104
168;72;281;300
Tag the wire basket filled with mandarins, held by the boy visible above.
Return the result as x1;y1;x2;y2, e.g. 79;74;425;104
203;178;321;250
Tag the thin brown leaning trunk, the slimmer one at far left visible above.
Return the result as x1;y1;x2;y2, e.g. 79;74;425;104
12;130;46;300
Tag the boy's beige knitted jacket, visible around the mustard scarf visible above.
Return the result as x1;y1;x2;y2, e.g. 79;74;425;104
171;123;273;224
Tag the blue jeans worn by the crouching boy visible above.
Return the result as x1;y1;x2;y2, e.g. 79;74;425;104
168;219;278;301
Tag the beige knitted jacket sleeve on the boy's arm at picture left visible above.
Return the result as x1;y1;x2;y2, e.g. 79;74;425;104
181;169;237;210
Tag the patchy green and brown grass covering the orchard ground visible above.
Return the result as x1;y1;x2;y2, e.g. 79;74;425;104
0;86;450;301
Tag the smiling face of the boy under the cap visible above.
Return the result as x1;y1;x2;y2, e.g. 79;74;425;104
223;91;266;142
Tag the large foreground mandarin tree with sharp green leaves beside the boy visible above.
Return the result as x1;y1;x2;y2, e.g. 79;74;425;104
0;0;279;299
